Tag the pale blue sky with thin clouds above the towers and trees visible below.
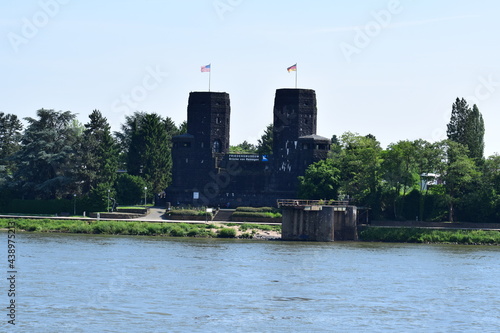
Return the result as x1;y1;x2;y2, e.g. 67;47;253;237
0;0;500;156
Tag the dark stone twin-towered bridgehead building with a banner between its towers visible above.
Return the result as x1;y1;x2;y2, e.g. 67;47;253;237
166;89;331;207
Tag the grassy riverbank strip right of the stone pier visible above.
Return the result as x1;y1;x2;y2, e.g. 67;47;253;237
359;227;500;245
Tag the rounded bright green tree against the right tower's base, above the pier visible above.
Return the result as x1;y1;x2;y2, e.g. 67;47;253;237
299;159;340;200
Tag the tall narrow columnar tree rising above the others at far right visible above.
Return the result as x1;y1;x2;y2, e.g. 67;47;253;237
447;98;484;162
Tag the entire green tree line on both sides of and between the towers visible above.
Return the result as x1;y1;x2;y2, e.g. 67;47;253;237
0;98;500;222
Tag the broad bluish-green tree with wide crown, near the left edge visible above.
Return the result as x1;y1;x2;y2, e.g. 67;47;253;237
13;109;79;199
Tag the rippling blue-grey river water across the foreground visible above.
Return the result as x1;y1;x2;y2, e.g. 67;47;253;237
0;233;500;333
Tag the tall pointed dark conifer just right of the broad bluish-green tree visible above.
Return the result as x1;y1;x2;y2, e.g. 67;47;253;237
78;110;118;194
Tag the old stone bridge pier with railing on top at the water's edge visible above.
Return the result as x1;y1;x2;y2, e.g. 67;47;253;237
278;200;358;242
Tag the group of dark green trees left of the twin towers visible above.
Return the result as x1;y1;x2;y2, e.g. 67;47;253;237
0;109;186;211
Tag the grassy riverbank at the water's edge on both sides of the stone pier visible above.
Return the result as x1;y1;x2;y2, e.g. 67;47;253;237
0;218;500;245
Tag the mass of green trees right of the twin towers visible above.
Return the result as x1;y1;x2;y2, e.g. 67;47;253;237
299;98;500;222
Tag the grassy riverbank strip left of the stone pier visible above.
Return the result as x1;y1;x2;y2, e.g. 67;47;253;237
0;219;281;239
